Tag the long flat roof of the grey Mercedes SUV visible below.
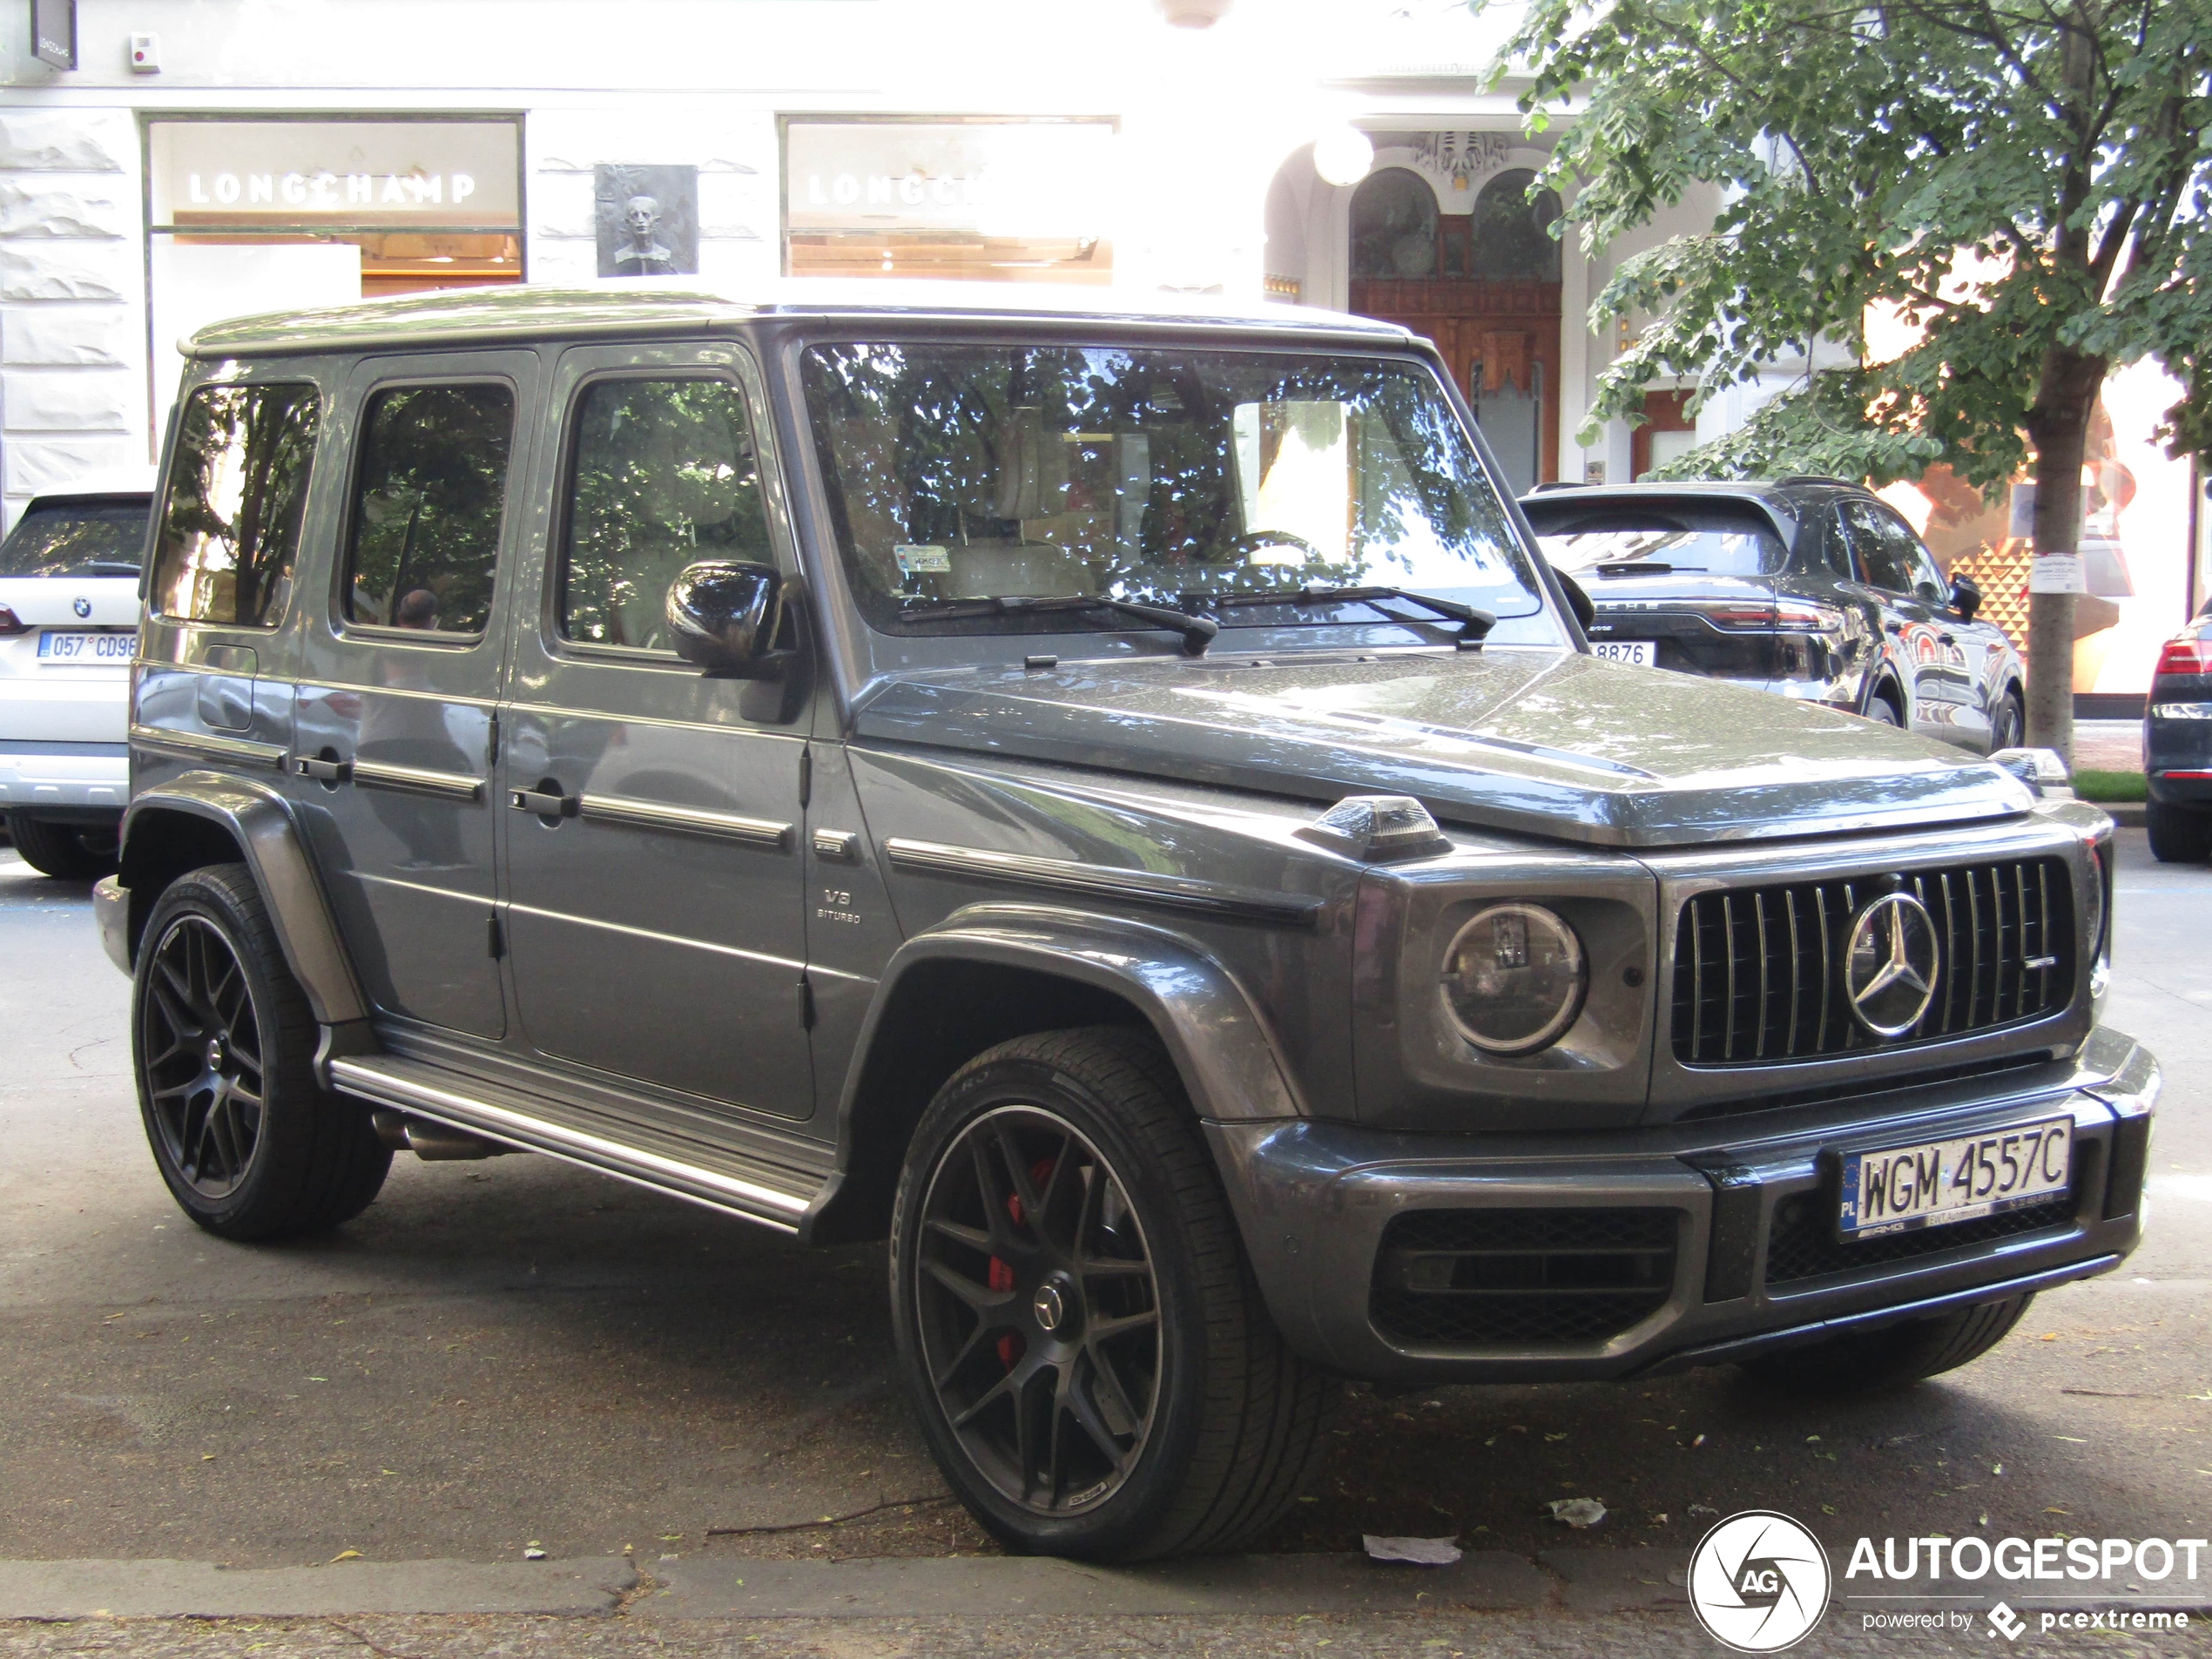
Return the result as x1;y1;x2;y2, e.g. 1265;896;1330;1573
177;277;1413;358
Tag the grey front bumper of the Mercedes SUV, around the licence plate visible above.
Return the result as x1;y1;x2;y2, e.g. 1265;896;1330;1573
1205;1028;2159;1385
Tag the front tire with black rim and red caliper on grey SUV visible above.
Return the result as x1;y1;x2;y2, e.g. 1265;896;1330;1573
892;1027;1339;1561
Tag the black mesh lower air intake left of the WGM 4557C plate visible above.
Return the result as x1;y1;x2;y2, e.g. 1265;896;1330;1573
1369;1210;1676;1347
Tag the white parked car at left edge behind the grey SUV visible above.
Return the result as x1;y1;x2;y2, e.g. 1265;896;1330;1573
0;475;152;880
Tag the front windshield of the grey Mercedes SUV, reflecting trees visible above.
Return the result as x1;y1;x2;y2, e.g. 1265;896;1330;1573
803;343;1560;644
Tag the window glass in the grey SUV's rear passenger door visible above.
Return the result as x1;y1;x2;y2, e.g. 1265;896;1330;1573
343;385;516;635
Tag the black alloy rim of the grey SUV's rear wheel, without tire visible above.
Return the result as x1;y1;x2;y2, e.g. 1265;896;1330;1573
139;914;267;1199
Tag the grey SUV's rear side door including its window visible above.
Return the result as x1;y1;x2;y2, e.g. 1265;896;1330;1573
292;352;540;1037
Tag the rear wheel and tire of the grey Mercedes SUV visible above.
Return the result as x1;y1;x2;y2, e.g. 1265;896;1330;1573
131;865;392;1238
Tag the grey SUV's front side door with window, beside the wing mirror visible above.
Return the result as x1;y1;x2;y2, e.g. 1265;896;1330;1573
498;345;812;1117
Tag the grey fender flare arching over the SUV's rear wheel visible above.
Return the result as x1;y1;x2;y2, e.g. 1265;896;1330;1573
122;770;369;1027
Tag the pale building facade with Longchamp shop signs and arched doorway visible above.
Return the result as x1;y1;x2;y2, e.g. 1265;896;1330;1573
0;0;2188;694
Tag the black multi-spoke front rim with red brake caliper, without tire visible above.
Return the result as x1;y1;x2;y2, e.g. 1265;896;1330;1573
916;1106;1162;1517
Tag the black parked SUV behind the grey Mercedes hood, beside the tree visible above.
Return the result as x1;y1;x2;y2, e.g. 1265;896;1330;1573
1522;478;2028;754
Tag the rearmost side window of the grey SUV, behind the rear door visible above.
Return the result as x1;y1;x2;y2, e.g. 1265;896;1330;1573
148;385;320;628
